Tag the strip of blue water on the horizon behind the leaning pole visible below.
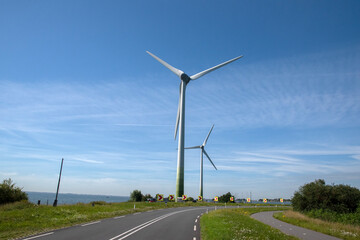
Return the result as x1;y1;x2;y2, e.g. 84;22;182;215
26;192;130;205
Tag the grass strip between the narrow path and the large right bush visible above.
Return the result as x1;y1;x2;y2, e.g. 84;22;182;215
274;211;360;240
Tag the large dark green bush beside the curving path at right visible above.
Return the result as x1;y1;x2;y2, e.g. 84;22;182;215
292;179;360;215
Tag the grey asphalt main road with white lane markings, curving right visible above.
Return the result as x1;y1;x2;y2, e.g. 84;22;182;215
23;207;214;240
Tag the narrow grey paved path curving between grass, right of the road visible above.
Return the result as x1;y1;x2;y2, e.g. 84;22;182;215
251;211;340;240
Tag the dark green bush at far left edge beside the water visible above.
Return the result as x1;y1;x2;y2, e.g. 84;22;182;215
0;178;28;204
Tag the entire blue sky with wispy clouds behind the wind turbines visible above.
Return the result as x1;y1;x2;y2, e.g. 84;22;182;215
0;0;360;199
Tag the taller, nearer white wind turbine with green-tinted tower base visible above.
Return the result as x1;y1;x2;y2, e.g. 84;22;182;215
146;51;242;201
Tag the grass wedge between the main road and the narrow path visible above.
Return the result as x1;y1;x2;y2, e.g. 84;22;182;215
200;207;297;240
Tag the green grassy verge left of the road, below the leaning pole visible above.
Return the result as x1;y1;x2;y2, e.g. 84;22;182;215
0;202;219;239
